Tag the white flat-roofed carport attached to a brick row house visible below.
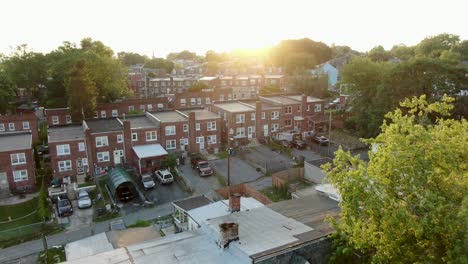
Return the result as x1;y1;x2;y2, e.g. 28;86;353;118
133;144;168;175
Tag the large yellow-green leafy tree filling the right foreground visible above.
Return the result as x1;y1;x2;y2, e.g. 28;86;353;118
325;96;468;263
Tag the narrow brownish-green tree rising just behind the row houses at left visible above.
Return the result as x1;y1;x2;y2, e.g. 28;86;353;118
66;60;97;122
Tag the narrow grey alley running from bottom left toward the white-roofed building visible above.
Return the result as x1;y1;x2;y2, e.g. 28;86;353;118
0;203;173;263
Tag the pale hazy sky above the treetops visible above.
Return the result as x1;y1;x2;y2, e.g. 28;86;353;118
0;0;468;56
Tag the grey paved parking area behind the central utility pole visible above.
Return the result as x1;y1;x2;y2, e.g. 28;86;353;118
210;157;263;185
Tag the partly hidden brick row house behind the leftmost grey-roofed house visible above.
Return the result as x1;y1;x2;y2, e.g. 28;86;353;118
0;113;39;142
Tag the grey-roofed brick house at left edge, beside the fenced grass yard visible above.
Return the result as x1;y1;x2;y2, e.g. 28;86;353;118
0;131;36;197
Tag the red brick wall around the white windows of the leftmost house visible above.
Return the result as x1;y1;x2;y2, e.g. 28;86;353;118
0;148;36;191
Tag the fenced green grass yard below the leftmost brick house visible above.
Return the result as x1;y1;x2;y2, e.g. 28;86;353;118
0;197;42;231
